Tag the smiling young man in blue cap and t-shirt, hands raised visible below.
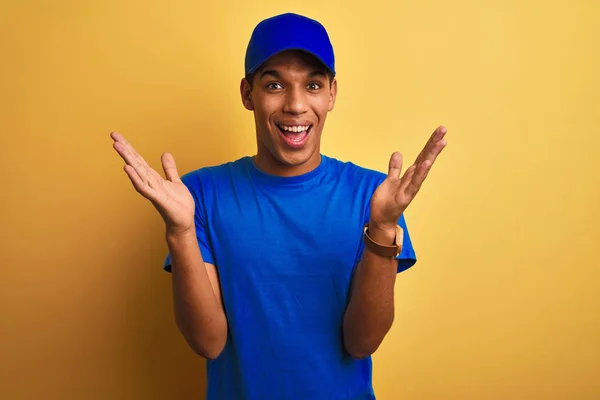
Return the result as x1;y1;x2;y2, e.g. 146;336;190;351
112;14;446;400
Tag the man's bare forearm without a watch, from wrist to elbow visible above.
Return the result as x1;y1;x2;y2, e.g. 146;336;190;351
167;232;227;358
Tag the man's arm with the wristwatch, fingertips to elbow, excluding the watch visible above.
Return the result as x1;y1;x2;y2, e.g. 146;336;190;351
342;127;446;358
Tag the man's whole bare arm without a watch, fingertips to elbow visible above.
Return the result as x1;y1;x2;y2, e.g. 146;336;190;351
111;132;227;358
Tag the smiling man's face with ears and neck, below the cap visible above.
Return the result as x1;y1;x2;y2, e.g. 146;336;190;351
241;51;337;176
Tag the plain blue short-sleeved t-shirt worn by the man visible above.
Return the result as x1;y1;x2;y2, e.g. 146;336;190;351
164;156;416;400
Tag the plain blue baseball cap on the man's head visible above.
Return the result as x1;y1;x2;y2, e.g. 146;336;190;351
245;13;335;76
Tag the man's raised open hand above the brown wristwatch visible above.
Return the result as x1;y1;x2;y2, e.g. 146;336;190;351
369;126;446;232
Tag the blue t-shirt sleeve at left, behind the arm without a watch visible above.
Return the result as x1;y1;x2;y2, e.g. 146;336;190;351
163;173;215;272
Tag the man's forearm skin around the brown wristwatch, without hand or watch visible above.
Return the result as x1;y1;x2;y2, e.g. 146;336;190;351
343;223;398;358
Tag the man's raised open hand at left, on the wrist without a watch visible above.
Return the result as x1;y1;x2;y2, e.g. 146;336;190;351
110;132;195;234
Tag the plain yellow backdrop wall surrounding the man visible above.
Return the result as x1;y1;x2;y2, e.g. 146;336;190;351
0;0;600;400
